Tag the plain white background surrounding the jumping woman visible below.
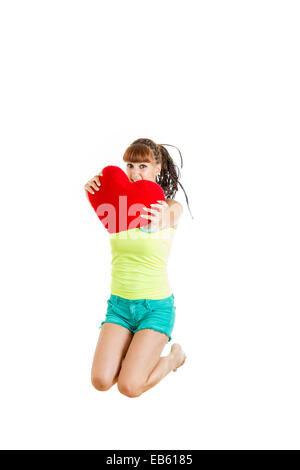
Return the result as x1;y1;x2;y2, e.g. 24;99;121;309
0;0;300;450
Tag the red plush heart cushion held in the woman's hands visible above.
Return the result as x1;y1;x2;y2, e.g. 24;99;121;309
88;165;166;233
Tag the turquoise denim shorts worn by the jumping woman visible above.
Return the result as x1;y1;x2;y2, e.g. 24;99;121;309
99;294;176;342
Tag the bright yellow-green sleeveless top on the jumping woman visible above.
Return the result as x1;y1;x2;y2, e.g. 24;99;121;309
110;227;175;299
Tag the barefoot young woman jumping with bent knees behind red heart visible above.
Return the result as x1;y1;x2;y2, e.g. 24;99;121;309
84;139;192;397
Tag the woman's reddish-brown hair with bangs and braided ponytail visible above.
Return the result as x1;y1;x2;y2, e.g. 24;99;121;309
123;138;194;219
